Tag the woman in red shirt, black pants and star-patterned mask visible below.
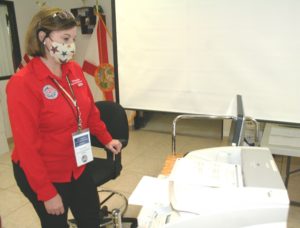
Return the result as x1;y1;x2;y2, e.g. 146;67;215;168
6;8;121;228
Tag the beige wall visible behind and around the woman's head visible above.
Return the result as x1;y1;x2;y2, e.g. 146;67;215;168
0;0;111;154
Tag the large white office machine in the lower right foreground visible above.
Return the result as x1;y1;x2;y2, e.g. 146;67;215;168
138;147;289;228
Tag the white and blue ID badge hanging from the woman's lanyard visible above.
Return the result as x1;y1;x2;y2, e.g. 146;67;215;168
72;129;94;167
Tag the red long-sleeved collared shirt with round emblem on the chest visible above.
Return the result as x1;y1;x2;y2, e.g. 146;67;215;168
6;57;112;201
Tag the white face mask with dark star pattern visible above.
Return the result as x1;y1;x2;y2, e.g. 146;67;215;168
50;41;76;64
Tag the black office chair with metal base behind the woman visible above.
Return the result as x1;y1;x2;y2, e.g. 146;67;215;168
70;101;137;227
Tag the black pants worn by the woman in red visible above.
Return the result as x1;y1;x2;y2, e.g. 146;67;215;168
13;162;100;228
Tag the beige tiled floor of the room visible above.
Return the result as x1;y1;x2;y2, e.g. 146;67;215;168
0;116;300;228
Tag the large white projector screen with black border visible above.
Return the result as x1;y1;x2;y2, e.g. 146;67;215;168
114;0;300;123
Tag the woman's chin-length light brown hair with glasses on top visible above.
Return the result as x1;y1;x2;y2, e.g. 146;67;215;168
25;8;76;56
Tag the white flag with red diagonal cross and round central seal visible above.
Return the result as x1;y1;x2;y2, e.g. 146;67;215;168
82;15;115;101
